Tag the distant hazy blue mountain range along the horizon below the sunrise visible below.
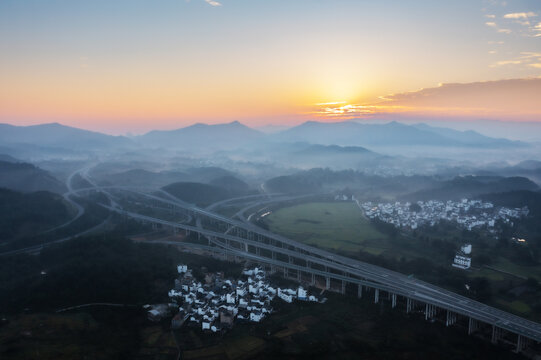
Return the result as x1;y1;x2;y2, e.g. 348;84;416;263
0;121;527;157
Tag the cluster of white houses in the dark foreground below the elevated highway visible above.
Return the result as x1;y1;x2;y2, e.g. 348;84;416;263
165;265;320;332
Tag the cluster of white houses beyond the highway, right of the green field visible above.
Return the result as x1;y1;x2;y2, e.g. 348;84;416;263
361;199;529;230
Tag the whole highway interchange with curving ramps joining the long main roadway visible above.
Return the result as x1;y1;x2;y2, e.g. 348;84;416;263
6;167;541;348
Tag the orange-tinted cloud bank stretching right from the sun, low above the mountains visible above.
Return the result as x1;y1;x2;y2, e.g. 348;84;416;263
312;78;541;120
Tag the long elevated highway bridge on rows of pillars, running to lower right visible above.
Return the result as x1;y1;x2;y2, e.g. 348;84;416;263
69;179;541;352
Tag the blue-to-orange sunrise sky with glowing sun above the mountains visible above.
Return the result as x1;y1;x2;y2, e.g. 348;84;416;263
0;0;541;134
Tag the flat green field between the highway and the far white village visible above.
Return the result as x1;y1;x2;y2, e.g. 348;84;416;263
264;202;389;255
